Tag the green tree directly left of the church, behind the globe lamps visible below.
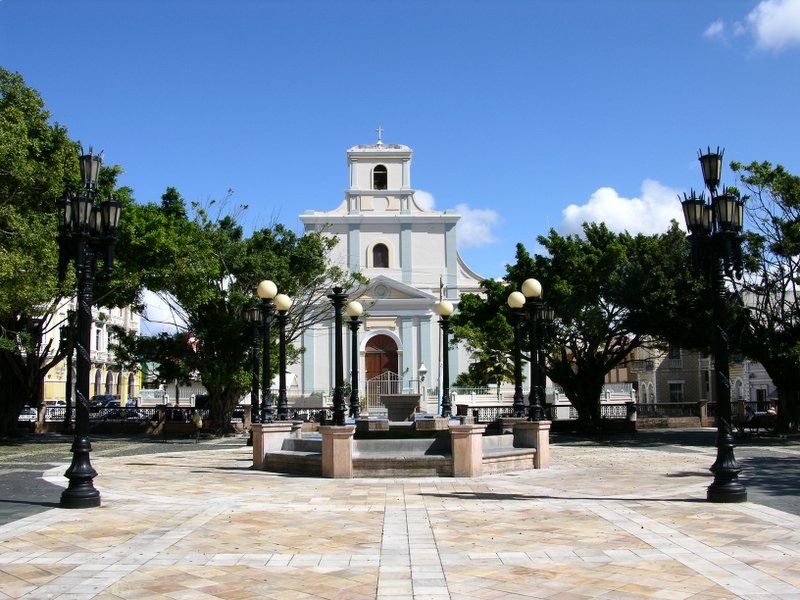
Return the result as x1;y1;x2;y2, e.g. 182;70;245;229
110;188;360;424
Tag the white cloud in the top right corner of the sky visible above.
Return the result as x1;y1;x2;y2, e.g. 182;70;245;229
703;0;800;51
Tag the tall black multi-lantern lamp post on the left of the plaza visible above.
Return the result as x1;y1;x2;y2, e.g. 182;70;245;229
58;148;121;508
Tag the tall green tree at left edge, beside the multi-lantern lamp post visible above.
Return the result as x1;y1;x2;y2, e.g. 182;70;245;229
0;68;78;437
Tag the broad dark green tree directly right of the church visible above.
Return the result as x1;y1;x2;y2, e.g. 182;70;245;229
453;224;702;427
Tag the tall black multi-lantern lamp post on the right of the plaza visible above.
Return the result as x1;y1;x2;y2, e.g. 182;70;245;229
681;148;747;502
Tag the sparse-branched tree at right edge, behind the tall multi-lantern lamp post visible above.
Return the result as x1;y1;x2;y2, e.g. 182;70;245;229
731;162;800;431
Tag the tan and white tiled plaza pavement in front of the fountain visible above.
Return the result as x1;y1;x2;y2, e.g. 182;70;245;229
0;432;800;600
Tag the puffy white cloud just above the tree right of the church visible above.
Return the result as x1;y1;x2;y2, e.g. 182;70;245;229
558;179;683;235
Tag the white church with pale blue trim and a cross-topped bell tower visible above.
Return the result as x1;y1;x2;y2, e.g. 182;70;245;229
290;128;481;412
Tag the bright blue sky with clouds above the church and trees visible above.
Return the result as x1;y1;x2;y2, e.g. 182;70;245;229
0;0;800;286
